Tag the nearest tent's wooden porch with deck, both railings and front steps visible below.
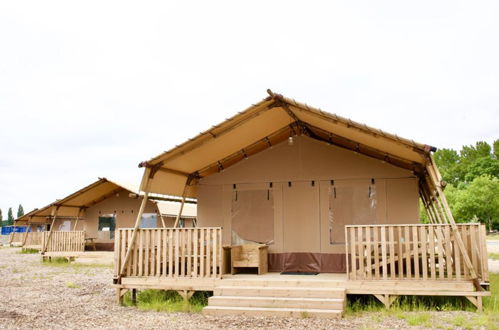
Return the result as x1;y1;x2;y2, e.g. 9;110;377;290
114;224;490;317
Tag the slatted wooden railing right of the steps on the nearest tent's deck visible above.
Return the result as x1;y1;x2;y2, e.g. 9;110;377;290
345;223;489;282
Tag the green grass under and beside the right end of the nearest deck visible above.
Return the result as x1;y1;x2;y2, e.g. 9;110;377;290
345;274;499;329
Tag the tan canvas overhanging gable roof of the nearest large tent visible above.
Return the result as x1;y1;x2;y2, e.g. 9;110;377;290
139;90;436;197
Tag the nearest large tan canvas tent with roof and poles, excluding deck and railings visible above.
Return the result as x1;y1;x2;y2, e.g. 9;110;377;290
125;91;473;273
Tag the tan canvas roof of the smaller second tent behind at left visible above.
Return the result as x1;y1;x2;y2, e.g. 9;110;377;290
16;178;143;223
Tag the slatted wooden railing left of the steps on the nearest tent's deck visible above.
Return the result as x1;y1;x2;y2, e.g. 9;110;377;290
114;227;222;278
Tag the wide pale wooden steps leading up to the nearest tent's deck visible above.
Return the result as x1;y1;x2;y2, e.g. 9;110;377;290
203;279;346;318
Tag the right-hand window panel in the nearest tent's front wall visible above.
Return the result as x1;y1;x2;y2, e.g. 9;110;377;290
329;181;377;244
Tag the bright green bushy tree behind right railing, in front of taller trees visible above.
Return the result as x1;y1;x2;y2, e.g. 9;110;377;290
452;175;499;230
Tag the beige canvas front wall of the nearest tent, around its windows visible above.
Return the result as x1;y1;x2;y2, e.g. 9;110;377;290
198;137;419;253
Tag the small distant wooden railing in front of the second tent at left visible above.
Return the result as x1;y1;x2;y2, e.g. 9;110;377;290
42;231;85;252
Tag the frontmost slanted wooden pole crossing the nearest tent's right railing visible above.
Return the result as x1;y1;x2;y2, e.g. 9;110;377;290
427;160;478;286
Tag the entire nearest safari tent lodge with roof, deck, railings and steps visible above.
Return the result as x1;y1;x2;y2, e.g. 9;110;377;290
114;91;489;317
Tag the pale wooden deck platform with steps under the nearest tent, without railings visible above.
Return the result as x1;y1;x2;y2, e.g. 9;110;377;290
115;273;490;317
